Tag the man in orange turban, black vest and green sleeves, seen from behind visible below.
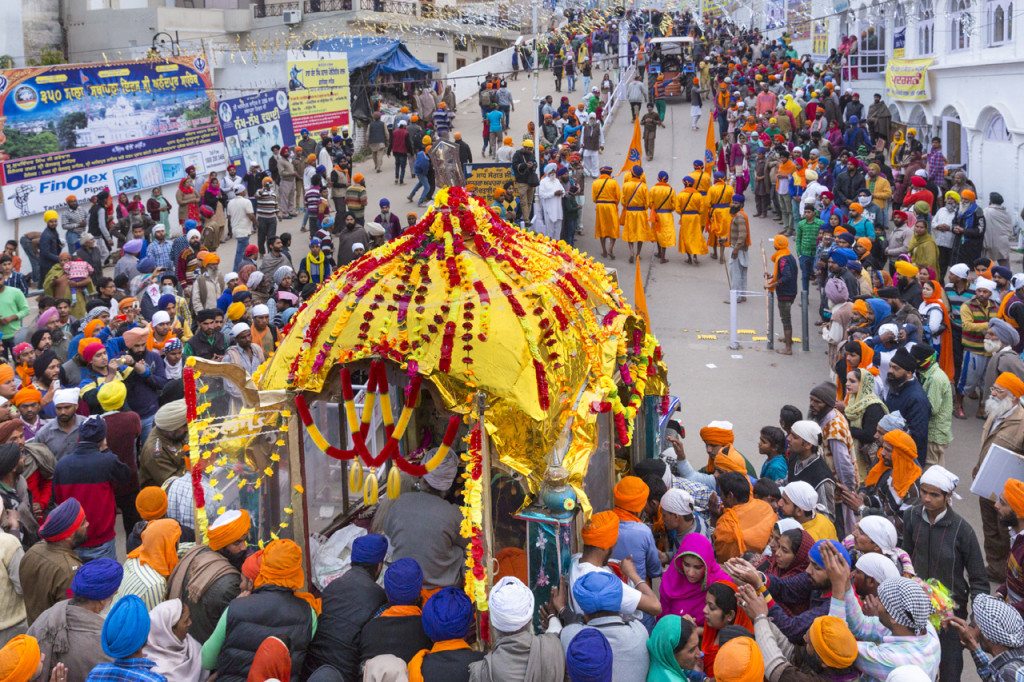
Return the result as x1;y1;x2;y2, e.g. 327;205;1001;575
203;540;326;680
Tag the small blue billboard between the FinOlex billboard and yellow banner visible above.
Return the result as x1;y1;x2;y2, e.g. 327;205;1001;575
217;90;295;175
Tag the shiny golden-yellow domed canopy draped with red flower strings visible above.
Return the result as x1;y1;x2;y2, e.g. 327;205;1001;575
255;187;667;503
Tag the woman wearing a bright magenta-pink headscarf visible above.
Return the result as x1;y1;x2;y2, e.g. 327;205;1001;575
659;532;731;626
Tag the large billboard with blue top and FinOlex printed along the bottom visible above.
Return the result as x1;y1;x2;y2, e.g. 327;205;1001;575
0;56;226;219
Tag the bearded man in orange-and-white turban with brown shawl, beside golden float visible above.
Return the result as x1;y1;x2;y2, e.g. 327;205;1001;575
167;509;251;642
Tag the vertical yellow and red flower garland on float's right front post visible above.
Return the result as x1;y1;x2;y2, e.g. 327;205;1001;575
460;422;487;613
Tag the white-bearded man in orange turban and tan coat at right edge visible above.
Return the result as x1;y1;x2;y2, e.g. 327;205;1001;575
971;372;1024;583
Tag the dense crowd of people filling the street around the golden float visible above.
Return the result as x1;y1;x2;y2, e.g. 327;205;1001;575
0;5;1024;682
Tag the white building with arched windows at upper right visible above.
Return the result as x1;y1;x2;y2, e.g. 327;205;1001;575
741;0;1024;214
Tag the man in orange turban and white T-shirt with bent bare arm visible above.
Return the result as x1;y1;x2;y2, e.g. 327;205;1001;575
567;507;662;617
